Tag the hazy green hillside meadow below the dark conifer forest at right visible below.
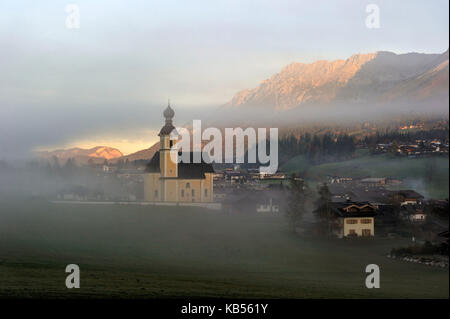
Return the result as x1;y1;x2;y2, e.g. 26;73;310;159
282;152;449;198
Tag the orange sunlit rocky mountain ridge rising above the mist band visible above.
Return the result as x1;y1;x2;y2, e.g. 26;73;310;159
226;51;448;110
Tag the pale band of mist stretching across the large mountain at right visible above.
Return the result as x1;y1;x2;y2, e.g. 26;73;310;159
205;97;449;129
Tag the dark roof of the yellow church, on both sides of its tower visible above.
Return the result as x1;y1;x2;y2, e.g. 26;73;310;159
146;152;214;179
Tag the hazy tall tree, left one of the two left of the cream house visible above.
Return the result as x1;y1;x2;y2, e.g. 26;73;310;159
286;174;305;233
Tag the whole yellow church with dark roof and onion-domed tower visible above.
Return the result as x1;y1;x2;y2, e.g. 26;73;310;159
144;104;214;203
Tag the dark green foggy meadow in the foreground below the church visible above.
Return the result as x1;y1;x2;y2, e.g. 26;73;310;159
0;200;449;298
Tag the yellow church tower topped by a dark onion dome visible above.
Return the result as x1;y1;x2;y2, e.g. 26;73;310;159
159;103;178;179
